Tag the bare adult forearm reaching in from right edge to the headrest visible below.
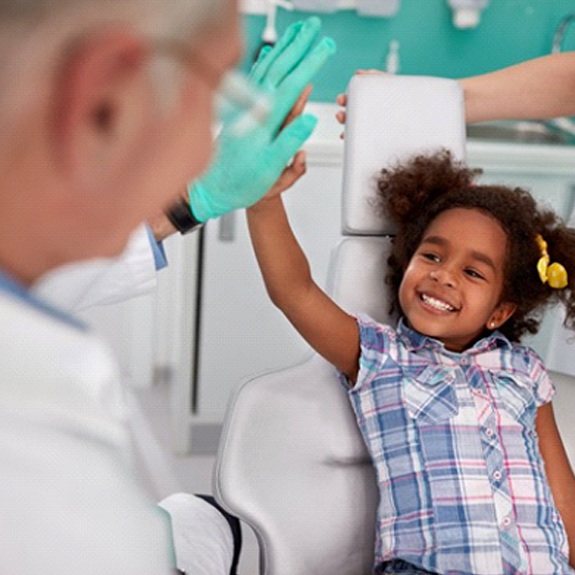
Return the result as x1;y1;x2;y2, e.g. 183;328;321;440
460;52;575;123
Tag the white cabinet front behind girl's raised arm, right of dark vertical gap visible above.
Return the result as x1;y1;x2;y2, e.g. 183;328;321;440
196;160;341;421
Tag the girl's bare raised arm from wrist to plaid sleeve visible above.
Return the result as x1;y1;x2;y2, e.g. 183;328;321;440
247;183;360;382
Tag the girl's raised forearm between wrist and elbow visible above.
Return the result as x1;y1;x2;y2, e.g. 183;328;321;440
246;197;313;311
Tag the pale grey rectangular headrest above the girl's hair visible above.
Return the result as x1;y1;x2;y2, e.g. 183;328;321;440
343;74;465;235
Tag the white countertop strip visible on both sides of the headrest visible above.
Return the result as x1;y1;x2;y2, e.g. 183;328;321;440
305;102;575;177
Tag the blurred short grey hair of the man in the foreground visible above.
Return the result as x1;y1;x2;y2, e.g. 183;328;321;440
0;0;233;129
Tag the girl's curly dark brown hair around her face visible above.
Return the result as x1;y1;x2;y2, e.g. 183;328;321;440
378;150;575;341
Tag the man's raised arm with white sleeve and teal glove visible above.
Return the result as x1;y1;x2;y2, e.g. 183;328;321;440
33;17;335;311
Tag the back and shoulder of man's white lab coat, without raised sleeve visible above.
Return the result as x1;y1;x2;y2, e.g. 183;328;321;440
0;293;176;575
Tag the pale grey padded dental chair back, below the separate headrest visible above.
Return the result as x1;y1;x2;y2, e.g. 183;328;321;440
214;237;396;575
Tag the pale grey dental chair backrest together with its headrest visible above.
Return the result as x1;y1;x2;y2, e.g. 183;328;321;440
214;75;465;575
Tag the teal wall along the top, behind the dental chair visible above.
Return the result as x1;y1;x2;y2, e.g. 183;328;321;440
243;0;575;101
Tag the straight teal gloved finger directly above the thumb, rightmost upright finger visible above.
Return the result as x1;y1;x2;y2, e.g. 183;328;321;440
267;37;336;133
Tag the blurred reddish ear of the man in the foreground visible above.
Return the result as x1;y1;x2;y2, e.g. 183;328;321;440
52;31;151;187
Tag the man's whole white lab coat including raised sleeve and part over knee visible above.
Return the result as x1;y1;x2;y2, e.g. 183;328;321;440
0;229;233;575
